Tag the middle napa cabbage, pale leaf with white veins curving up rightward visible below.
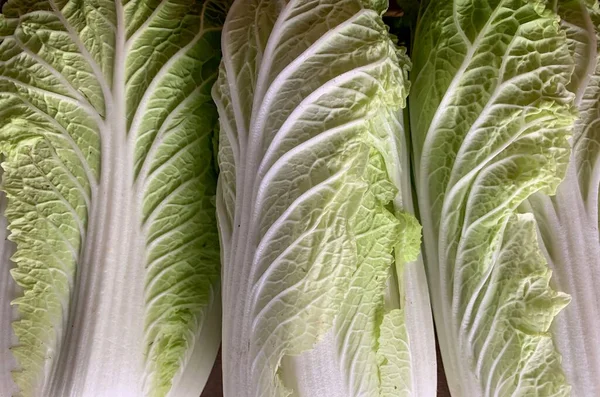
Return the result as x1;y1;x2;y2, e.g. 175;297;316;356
213;0;436;397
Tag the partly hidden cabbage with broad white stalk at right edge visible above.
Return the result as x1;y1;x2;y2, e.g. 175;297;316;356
529;0;600;396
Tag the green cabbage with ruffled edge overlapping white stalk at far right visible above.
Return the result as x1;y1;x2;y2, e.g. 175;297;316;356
410;0;574;396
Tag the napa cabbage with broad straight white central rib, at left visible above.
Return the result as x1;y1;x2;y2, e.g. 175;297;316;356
0;0;226;396
